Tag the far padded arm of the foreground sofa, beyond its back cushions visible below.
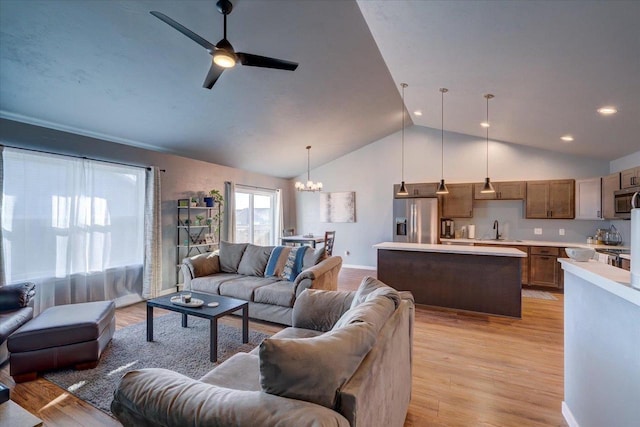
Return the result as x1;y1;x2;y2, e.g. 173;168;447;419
291;289;355;332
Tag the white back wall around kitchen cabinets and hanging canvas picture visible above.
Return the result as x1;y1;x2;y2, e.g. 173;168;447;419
298;126;609;267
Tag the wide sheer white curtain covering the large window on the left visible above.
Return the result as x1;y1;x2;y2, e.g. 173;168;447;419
2;148;145;312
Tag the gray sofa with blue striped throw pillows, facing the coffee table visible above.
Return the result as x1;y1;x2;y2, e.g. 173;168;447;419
180;242;342;326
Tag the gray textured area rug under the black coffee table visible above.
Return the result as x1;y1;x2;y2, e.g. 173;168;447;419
44;313;268;415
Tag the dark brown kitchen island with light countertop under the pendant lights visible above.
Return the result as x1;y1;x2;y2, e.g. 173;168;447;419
373;242;527;318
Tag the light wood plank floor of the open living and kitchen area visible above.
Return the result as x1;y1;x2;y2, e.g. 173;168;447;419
0;268;567;427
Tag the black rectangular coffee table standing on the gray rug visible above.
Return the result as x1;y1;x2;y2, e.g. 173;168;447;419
147;292;249;362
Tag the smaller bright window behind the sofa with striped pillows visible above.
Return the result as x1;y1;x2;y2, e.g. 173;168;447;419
235;185;278;246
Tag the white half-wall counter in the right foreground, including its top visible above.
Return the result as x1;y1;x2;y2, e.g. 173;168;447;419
560;259;640;427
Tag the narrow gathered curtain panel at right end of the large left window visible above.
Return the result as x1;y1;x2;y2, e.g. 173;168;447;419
142;166;162;298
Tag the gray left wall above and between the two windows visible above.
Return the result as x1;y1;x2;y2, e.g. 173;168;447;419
0;119;295;289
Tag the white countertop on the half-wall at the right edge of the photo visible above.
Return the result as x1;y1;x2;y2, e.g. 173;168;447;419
558;258;640;306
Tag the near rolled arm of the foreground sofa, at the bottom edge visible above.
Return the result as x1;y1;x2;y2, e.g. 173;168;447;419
111;368;349;427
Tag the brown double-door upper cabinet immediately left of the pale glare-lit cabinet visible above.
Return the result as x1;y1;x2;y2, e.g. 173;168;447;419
525;179;575;219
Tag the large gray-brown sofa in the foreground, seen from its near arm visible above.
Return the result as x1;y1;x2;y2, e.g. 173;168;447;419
111;277;414;427
